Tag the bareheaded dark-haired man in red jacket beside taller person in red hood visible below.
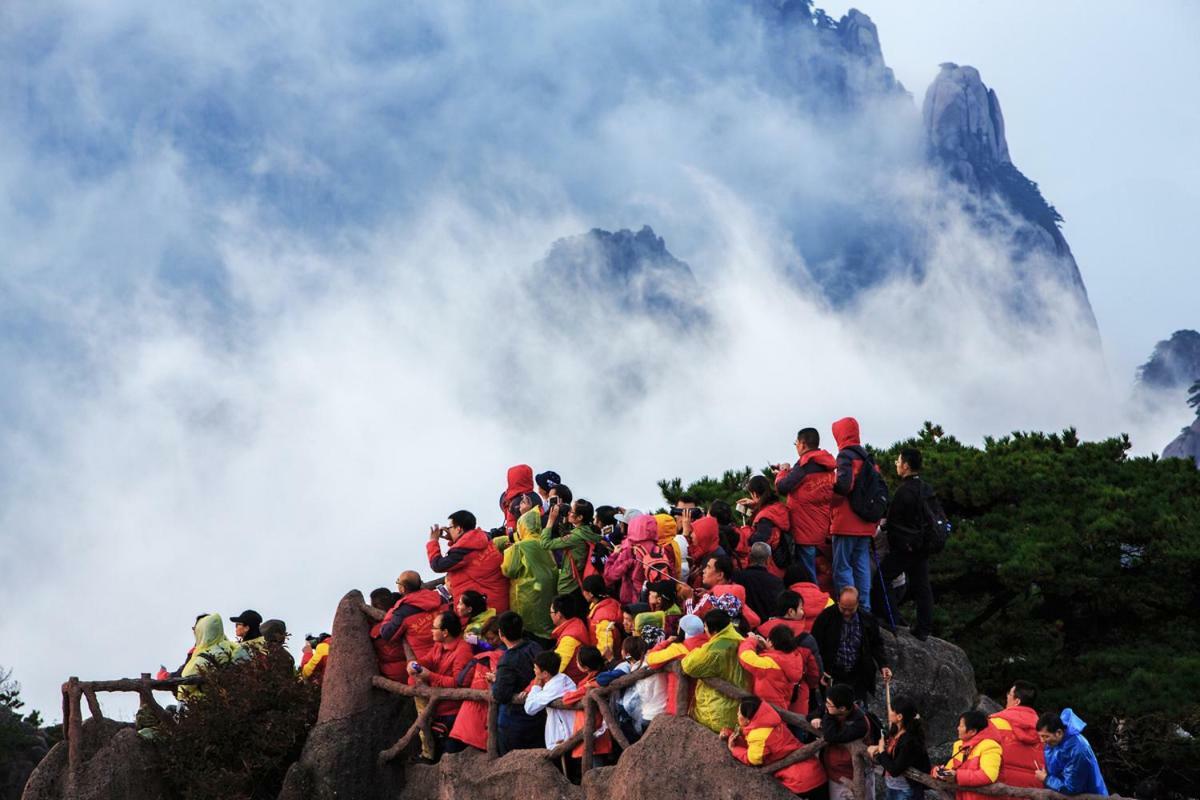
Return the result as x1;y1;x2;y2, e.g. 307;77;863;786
775;428;838;583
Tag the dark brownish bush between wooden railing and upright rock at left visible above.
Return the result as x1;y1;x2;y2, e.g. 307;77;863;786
156;650;320;800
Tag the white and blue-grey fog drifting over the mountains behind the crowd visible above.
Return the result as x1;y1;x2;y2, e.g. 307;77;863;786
0;2;1162;720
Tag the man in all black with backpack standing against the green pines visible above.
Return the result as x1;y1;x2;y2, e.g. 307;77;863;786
871;447;934;642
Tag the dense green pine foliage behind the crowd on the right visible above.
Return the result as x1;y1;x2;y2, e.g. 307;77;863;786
661;422;1200;790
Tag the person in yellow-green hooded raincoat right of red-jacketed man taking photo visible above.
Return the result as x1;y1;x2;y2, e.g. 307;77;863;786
500;506;558;639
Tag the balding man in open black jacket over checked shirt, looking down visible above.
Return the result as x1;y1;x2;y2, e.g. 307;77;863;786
812;587;892;703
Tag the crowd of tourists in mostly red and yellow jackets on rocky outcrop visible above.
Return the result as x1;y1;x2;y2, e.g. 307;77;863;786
163;417;1106;800
